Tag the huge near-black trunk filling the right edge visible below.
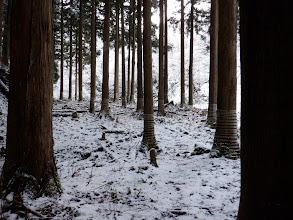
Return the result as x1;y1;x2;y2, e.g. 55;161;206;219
238;0;293;220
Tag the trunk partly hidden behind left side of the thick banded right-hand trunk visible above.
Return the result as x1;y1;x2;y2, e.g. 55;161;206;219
207;0;219;125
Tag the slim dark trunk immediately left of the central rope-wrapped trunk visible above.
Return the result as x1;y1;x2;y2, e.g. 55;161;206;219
137;0;143;112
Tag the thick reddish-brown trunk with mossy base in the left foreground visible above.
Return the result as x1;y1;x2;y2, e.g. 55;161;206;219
2;0;57;195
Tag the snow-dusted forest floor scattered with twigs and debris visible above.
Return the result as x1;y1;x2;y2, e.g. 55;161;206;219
0;101;240;220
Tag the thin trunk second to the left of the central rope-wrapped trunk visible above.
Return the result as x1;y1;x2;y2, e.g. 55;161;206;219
129;0;135;102
